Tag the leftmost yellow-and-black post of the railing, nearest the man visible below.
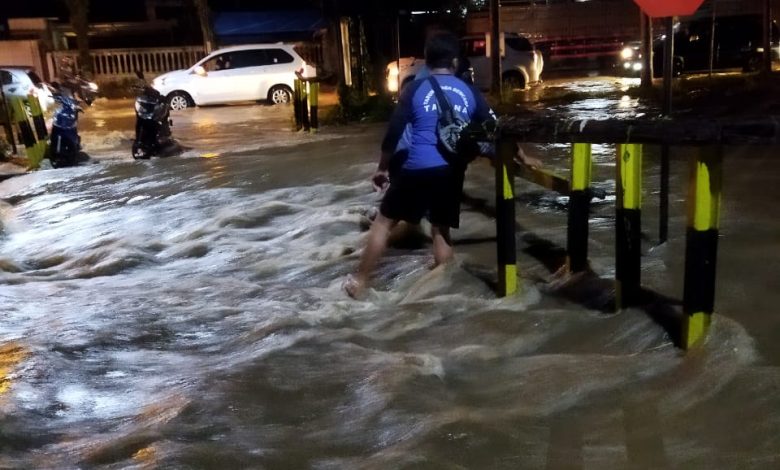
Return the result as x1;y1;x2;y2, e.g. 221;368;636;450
495;136;518;297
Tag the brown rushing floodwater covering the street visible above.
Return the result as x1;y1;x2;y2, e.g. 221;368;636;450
0;80;780;469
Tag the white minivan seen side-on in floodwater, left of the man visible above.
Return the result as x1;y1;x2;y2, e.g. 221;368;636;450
152;43;314;111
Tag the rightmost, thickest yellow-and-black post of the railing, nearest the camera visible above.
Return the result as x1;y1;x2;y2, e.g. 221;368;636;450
681;146;723;349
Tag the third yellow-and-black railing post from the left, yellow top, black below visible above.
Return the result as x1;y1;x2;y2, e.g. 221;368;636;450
615;144;642;309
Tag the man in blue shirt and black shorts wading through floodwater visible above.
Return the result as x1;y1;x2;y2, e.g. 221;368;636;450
344;32;538;298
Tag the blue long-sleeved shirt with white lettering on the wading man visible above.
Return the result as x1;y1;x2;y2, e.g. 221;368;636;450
382;74;496;170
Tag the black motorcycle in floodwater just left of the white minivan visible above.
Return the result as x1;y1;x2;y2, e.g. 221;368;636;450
132;73;181;160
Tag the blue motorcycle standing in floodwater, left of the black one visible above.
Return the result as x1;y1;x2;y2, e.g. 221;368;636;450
48;89;89;168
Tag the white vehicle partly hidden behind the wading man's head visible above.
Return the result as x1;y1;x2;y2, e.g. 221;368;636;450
386;33;544;93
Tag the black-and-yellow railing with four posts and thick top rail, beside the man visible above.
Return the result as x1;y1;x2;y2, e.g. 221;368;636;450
495;116;780;349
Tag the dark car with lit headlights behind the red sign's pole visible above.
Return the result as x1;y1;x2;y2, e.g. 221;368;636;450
621;15;780;76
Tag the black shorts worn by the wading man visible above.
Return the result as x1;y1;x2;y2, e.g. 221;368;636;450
379;166;463;228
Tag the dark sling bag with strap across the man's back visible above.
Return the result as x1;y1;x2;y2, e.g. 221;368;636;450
428;76;480;166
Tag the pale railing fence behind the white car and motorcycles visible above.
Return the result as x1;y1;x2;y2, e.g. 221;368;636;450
47;46;206;81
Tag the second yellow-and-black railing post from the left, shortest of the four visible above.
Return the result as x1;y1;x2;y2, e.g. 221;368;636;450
567;144;592;273
